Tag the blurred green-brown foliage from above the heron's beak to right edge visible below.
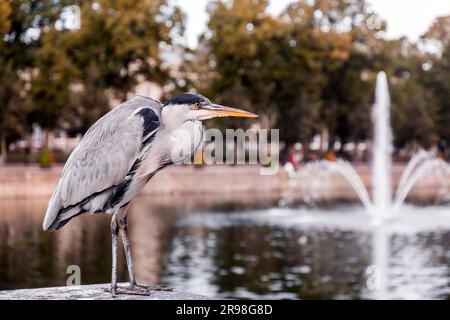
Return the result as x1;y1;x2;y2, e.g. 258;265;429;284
198;0;450;155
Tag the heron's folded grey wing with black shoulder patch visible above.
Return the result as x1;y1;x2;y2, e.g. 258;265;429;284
43;97;161;230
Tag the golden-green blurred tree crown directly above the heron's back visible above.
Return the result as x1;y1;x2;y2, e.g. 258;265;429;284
64;0;184;100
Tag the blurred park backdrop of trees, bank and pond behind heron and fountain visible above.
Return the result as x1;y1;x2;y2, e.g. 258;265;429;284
0;0;450;299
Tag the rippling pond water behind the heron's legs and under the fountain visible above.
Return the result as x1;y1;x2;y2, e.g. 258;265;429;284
0;195;450;299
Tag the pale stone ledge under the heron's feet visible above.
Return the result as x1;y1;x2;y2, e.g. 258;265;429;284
0;283;211;300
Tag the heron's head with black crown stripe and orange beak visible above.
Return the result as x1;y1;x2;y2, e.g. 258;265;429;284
162;93;257;127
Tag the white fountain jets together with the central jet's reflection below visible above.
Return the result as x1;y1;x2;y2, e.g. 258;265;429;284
282;72;449;299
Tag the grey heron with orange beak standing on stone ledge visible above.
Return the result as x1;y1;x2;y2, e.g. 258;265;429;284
43;93;256;295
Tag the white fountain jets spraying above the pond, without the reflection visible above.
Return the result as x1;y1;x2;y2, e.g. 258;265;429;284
291;72;448;220
